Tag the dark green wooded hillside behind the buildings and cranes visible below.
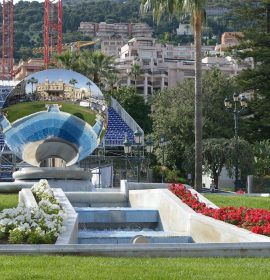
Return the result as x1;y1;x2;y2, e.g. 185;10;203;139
0;0;251;60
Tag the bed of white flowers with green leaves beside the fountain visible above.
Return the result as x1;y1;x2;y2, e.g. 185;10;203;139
0;180;64;244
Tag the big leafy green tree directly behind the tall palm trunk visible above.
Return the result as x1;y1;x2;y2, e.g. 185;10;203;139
152;69;234;174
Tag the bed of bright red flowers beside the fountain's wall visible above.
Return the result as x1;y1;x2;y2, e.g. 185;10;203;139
170;184;270;236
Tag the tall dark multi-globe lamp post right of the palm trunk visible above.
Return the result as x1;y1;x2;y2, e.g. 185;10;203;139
224;93;247;191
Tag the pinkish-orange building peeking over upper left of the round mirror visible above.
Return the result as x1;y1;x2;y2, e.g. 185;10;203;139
14;58;44;81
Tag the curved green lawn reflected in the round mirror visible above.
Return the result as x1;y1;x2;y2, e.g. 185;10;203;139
4;101;96;125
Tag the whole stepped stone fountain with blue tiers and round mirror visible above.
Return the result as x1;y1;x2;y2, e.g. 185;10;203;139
0;69;270;257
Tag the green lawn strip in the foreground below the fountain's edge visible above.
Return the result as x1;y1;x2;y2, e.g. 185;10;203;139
0;256;270;280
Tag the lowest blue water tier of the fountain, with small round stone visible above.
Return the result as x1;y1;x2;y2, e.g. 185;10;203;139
78;230;193;244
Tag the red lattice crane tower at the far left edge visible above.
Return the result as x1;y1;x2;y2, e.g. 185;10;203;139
2;0;14;80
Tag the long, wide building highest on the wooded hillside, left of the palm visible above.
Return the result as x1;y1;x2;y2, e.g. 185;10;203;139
79;22;153;39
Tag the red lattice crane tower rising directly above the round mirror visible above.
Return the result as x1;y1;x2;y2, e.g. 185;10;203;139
44;0;63;69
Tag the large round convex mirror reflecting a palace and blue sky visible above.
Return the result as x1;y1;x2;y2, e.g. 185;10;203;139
0;69;108;166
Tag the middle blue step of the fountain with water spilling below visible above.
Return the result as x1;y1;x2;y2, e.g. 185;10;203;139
75;207;159;229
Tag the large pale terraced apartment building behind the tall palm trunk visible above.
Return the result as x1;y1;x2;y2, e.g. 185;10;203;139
116;37;243;101
